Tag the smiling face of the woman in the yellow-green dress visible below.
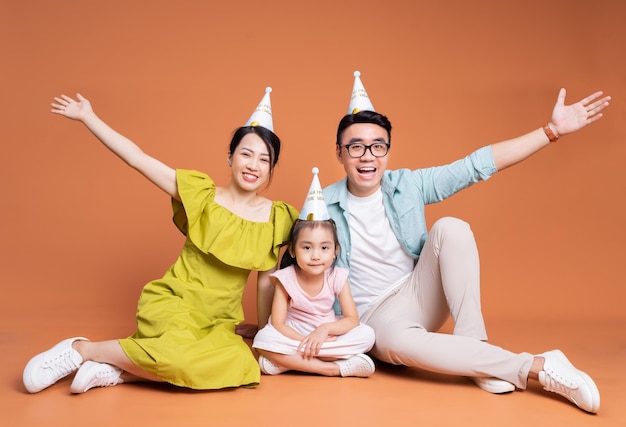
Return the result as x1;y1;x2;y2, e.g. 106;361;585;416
230;133;271;191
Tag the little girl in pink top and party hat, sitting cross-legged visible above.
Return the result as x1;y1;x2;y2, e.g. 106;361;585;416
253;168;375;377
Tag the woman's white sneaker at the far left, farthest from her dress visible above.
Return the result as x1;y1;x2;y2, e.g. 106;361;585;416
22;337;89;393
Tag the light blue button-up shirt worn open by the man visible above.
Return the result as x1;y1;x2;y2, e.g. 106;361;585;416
324;146;497;268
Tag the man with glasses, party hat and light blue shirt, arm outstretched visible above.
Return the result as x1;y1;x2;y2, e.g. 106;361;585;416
324;72;610;413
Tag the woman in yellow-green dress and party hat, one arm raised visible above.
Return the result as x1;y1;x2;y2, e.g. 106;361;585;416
23;88;298;393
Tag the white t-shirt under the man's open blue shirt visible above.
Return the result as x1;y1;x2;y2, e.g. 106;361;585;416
348;189;415;315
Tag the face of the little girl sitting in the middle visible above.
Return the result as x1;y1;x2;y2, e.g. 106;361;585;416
292;227;337;275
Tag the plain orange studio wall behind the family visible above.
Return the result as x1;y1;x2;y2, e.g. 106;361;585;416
0;0;626;427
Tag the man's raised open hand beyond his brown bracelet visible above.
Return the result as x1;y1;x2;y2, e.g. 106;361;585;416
552;89;611;135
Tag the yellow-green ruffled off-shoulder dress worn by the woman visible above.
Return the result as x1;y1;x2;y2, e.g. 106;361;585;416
119;170;298;390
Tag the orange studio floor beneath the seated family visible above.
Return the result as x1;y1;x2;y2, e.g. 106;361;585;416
0;312;626;427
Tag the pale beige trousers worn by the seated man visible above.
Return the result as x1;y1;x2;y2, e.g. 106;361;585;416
361;217;533;389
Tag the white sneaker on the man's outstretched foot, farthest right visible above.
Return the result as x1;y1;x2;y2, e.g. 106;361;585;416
538;350;600;414
